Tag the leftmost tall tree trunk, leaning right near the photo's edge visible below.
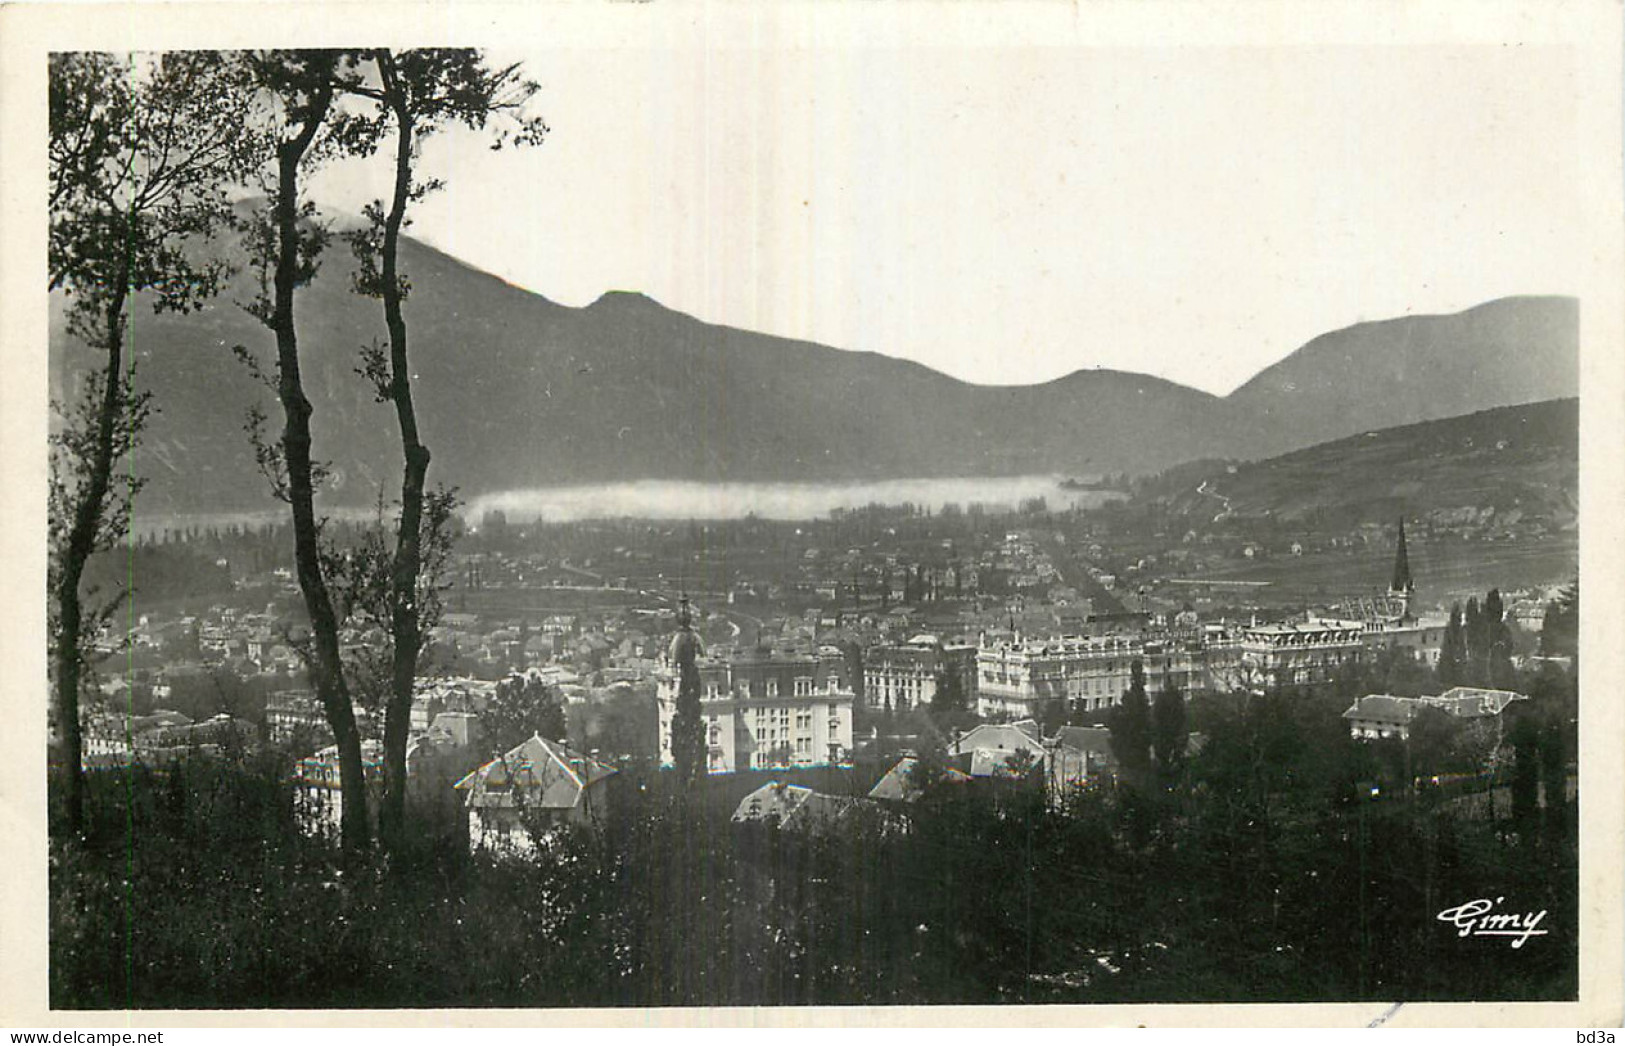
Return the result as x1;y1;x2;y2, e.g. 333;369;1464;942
57;276;130;833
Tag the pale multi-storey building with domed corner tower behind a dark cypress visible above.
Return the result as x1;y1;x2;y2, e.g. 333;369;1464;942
655;646;853;773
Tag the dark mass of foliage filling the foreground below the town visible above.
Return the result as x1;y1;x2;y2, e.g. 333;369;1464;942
50;665;1578;1009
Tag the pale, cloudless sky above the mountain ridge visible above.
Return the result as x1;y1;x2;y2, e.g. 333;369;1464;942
314;23;1584;395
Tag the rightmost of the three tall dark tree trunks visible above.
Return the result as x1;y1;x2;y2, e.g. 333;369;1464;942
379;59;429;848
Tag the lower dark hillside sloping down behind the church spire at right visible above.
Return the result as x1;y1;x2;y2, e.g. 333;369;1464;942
1141;400;1580;531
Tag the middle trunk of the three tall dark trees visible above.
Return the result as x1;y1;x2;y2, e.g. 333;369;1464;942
270;84;371;854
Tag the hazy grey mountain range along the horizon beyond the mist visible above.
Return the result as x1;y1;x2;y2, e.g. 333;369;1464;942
50;219;1580;515
